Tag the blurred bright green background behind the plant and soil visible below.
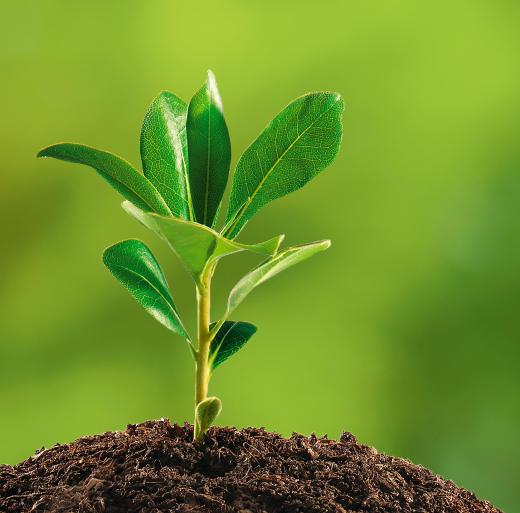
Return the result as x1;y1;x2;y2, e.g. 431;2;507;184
0;0;520;512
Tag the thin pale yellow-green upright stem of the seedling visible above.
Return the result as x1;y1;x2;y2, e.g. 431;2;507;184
195;268;213;435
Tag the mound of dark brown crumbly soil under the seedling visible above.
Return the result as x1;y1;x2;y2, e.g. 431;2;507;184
0;421;499;513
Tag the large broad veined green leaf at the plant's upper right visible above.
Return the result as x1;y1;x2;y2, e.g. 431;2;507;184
223;93;344;238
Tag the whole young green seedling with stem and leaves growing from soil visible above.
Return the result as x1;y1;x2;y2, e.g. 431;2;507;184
38;72;344;440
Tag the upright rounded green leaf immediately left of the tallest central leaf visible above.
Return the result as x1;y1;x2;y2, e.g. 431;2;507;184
141;92;193;219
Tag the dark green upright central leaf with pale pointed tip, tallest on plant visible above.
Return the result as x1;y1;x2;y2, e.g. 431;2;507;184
186;71;231;227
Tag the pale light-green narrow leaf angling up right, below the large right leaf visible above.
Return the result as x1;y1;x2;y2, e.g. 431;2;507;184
226;240;330;317
